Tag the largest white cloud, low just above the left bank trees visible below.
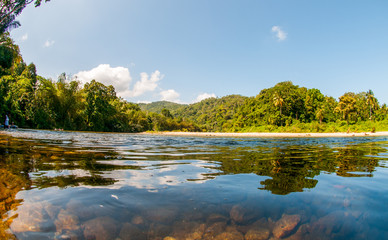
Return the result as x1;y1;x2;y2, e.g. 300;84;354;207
75;64;132;97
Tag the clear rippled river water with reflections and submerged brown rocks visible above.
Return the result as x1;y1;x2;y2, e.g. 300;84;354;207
0;130;388;240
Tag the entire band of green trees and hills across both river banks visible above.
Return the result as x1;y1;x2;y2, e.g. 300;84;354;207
0;33;388;132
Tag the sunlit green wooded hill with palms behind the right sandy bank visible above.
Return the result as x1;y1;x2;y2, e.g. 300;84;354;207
169;82;388;132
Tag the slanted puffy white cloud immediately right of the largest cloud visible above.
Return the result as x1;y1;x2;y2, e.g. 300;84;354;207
130;70;163;97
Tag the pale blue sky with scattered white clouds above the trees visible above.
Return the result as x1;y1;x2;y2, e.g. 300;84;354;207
11;0;388;103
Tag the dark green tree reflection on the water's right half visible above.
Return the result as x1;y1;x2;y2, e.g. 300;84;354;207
215;143;387;195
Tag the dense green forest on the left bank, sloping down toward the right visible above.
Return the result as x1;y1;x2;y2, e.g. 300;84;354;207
0;33;199;132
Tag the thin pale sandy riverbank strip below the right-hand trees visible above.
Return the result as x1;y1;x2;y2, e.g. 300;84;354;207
141;132;388;138
